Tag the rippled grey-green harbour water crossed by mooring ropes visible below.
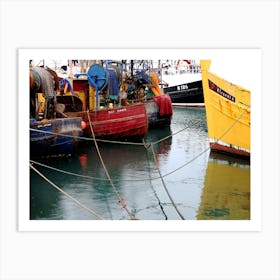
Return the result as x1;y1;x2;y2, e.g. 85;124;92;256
30;108;250;220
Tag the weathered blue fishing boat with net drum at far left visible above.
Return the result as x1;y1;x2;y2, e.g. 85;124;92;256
30;67;85;158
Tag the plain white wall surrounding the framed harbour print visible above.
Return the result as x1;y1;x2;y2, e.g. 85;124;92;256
0;0;280;280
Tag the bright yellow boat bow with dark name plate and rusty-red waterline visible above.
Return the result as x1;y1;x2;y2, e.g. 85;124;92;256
200;60;251;157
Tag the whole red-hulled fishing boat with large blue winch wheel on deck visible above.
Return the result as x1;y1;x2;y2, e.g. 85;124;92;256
57;62;148;140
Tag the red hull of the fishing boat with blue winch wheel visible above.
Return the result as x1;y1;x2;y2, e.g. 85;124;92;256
66;104;148;140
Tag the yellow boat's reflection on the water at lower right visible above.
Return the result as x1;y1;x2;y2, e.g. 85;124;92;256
197;153;250;220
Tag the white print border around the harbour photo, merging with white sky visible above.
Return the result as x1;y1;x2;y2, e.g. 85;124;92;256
18;49;262;231
